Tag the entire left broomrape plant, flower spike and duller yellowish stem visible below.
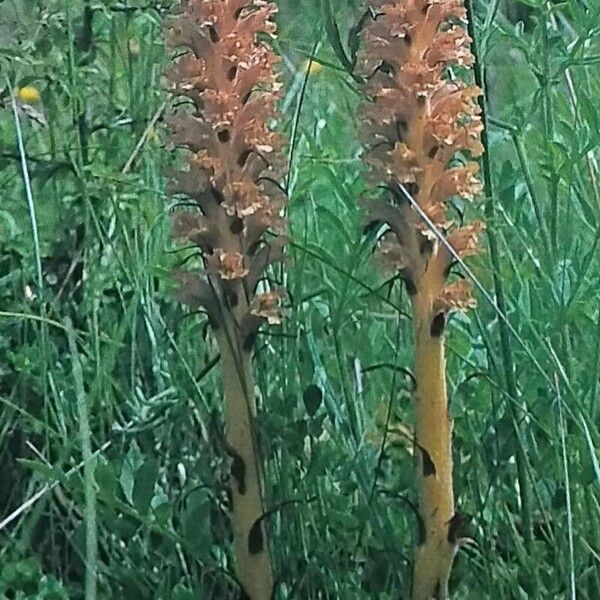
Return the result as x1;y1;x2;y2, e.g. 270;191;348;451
164;0;285;600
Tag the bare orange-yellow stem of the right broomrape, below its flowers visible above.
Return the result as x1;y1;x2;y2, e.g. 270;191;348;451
412;261;456;600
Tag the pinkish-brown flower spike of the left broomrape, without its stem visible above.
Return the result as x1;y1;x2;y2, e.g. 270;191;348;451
168;0;285;336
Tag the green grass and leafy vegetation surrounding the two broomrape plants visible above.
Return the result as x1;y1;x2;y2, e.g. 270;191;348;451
0;0;600;600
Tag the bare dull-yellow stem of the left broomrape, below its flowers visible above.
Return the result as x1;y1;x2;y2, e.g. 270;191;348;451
217;328;273;600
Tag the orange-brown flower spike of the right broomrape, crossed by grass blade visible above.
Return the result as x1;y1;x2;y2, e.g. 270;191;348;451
359;0;483;311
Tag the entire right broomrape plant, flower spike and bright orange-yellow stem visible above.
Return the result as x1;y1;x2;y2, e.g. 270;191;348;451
360;0;483;600
